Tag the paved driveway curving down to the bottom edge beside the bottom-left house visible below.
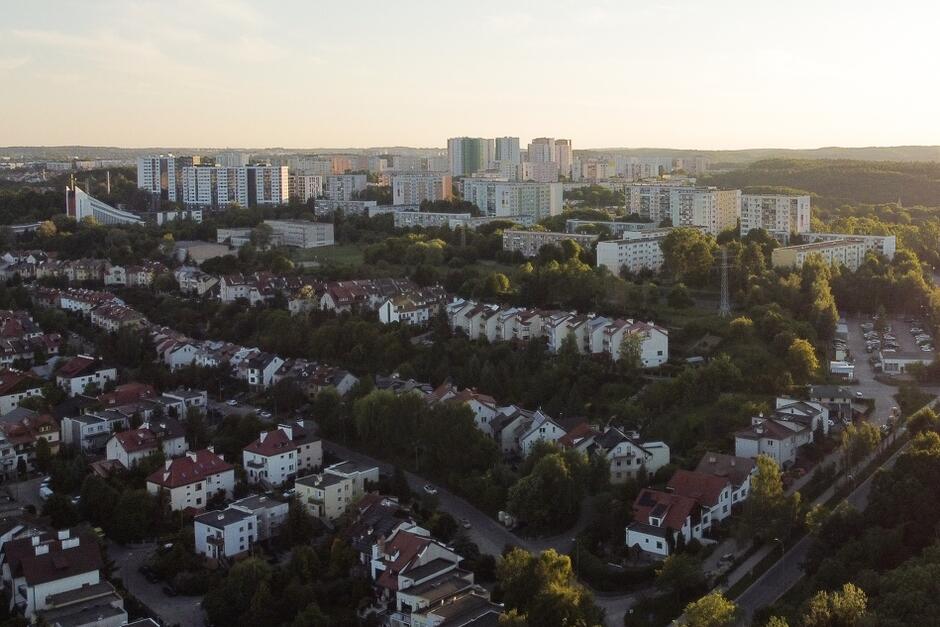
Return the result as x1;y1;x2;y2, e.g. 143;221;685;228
107;540;205;627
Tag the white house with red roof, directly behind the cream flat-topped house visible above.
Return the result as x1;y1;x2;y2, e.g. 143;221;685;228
242;420;323;487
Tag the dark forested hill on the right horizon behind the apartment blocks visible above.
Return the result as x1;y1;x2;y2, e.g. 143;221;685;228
699;159;940;207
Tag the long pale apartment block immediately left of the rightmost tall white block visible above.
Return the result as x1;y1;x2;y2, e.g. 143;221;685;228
625;183;720;235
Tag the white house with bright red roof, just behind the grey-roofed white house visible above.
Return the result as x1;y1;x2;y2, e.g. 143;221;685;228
147;446;235;511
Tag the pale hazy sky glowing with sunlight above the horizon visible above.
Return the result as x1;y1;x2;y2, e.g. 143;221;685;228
0;0;940;149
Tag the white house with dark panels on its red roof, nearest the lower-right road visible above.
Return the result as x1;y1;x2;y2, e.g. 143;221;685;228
626;488;703;557
